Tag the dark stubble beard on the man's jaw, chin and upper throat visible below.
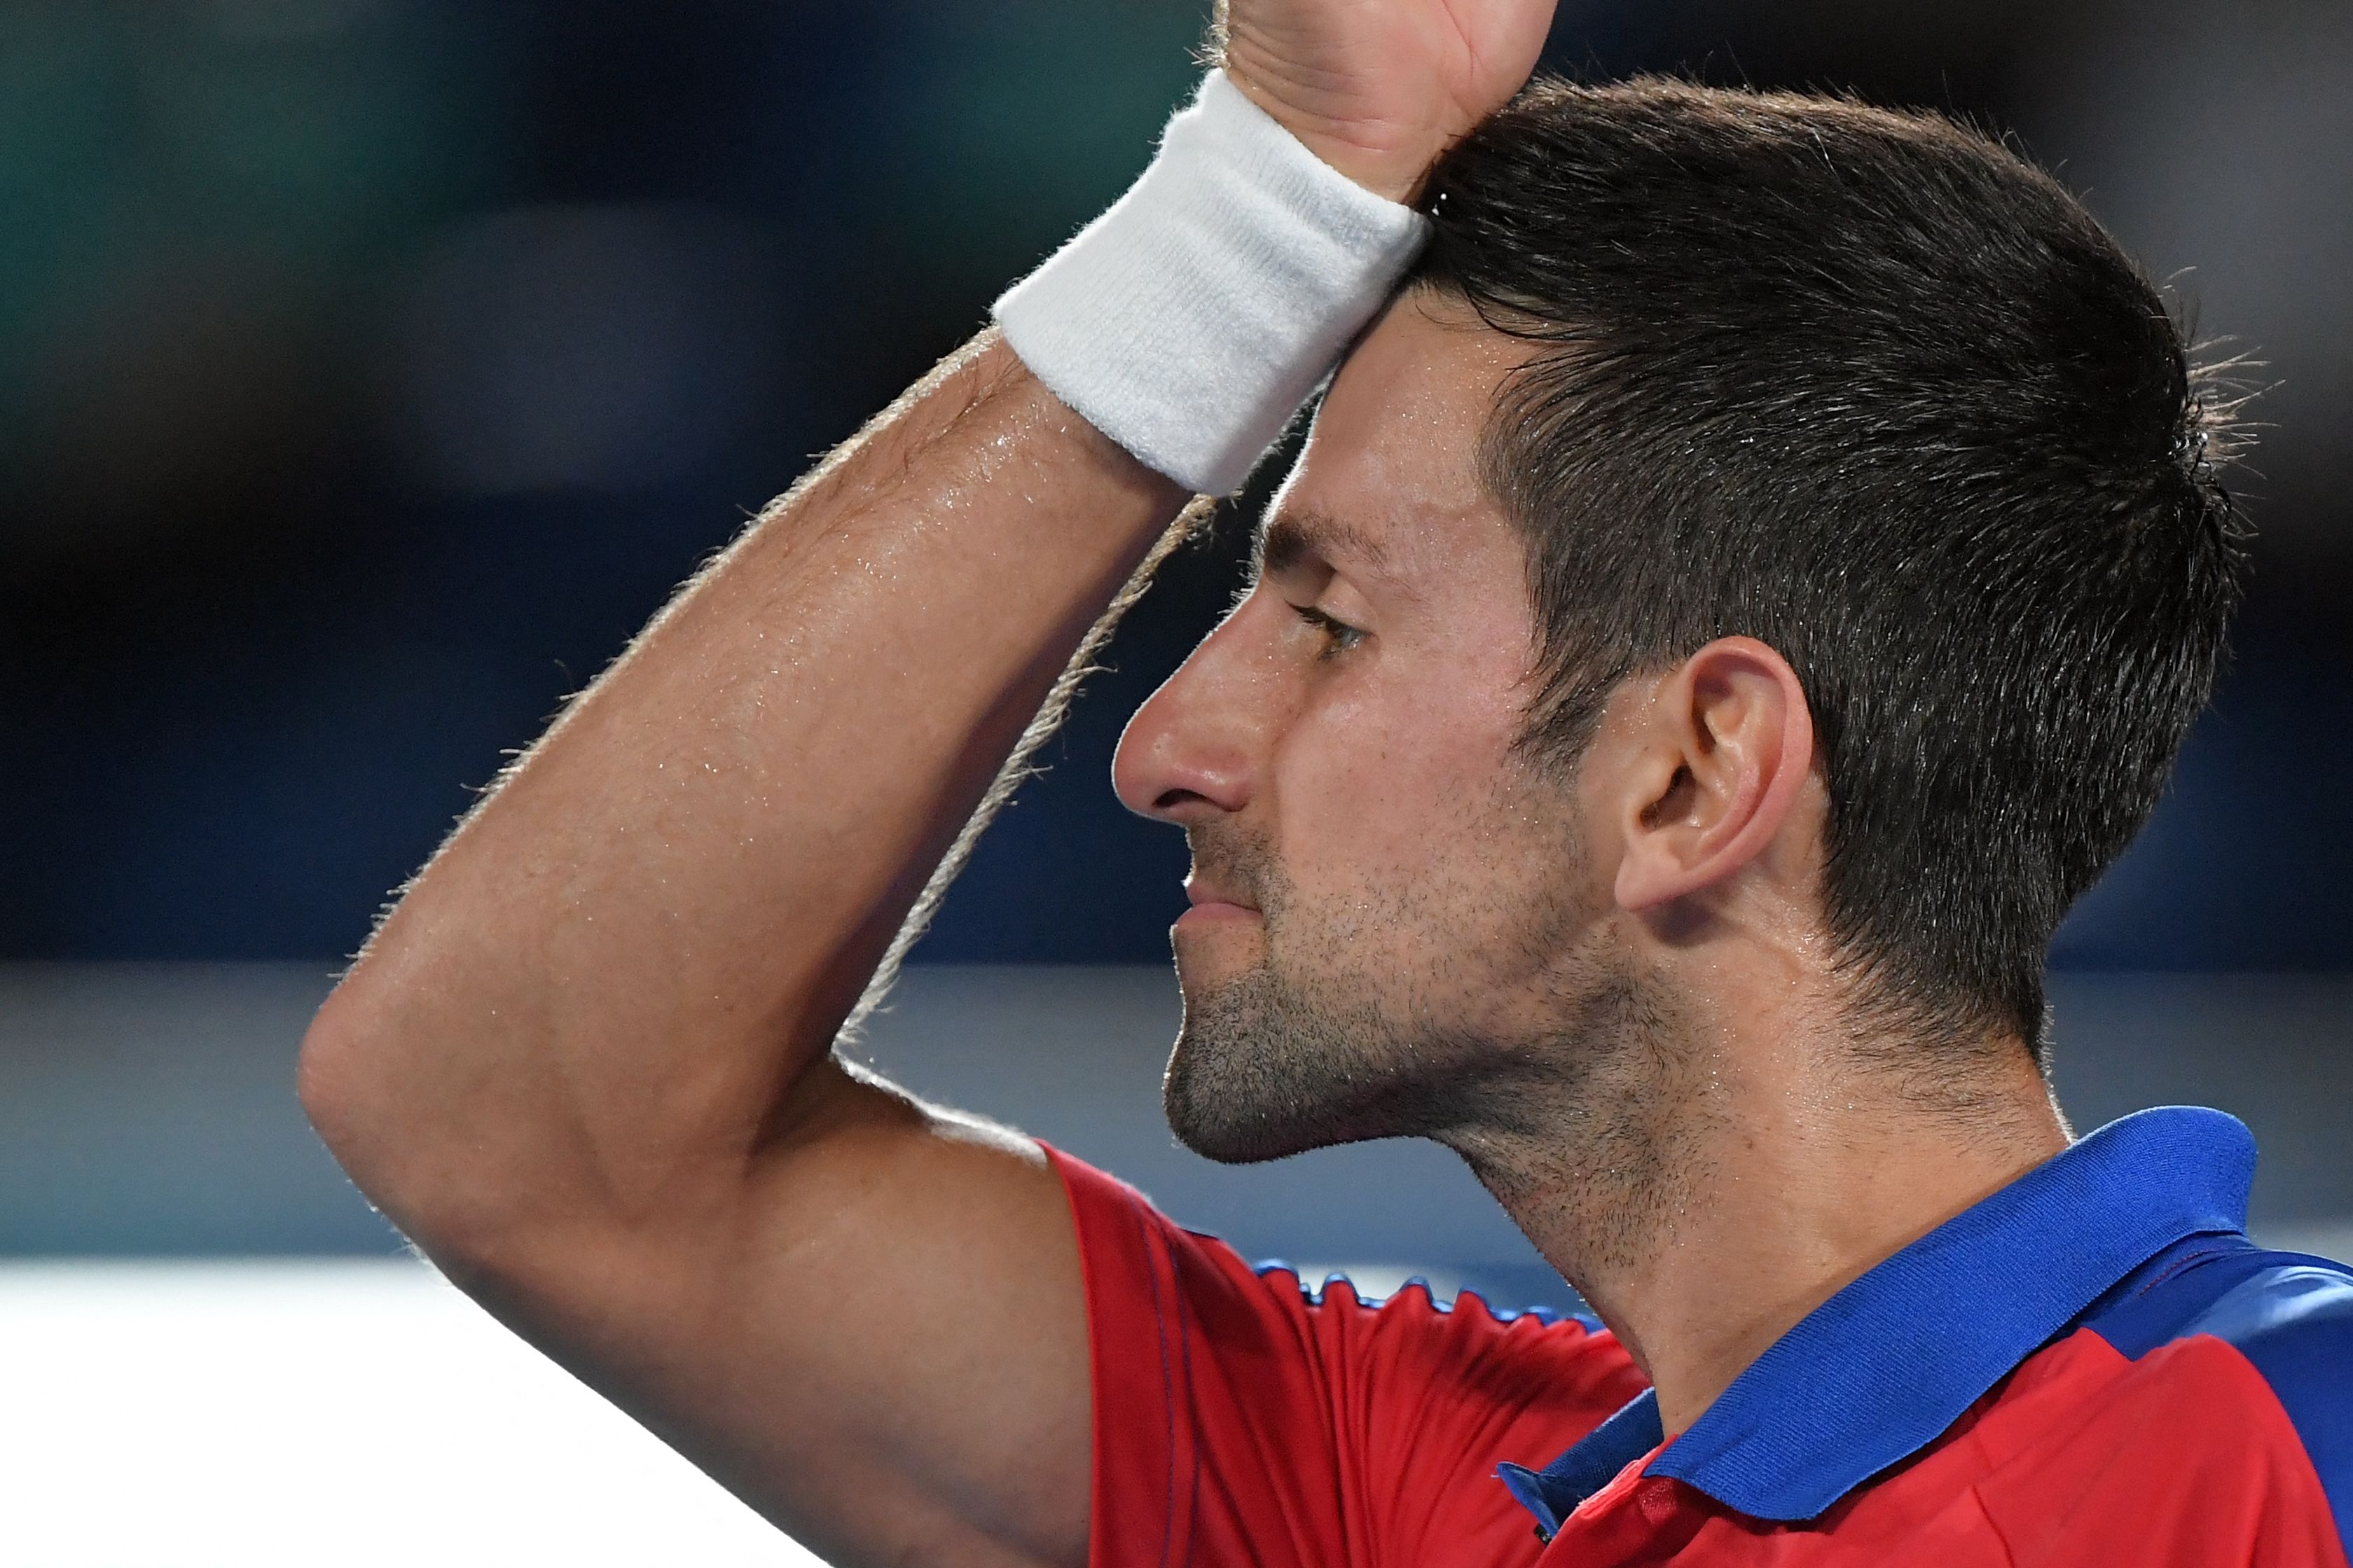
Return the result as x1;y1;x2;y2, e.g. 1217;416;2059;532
1162;808;1716;1293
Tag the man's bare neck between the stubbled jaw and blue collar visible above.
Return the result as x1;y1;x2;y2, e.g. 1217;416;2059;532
1447;973;2069;1434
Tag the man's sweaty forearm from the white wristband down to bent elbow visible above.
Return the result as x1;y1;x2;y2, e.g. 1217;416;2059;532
303;336;1184;1230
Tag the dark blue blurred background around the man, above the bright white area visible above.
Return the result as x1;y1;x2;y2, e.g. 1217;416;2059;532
0;0;2353;1291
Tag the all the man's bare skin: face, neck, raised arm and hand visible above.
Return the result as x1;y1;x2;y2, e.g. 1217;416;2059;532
301;0;2066;1563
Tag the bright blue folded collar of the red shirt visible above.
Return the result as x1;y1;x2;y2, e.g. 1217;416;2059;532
1501;1105;2254;1535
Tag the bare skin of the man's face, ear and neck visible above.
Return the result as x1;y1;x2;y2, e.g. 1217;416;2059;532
1113;294;2066;1431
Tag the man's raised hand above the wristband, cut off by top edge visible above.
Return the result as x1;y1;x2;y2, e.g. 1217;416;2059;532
1212;0;1553;202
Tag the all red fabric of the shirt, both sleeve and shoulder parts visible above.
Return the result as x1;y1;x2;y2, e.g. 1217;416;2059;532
1047;1149;2348;1568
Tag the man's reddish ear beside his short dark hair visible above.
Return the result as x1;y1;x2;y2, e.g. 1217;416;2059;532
1610;637;1814;910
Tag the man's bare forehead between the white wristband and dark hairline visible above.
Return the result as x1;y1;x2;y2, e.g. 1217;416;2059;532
1269;291;1532;585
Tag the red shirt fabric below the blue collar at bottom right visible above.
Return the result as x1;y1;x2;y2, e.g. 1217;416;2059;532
1544;1331;2346;1568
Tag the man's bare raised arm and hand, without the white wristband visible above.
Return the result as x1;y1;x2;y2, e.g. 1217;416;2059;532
301;0;1551;1563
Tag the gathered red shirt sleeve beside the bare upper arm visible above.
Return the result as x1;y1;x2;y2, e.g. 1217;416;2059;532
1047;1149;1645;1568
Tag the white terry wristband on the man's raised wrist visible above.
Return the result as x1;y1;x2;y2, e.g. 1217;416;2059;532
995;71;1428;496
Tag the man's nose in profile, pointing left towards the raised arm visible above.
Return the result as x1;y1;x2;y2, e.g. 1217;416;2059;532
1110;595;1280;828
